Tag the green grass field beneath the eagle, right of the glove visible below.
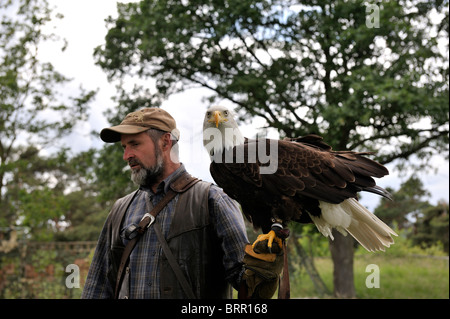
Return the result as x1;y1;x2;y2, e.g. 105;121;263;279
291;254;449;299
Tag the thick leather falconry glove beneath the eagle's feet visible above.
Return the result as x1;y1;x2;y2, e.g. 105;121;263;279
242;240;283;299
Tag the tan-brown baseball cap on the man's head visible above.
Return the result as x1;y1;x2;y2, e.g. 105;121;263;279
100;107;180;143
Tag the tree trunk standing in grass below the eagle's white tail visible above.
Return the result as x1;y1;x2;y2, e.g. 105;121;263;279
330;229;356;298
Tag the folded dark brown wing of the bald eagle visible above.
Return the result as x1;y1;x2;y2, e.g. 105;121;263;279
211;135;389;203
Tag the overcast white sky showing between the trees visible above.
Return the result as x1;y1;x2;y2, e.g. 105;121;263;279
40;0;449;209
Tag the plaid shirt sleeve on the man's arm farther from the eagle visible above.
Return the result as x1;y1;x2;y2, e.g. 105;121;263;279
81;216;114;299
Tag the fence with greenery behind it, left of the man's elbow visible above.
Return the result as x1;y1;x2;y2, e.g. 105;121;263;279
0;241;96;299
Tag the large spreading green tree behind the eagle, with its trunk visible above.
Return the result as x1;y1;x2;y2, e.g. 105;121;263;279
95;0;449;297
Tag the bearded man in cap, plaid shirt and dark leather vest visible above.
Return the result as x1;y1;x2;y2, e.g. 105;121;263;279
82;108;279;299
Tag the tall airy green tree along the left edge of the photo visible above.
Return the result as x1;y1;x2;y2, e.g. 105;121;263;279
0;0;95;238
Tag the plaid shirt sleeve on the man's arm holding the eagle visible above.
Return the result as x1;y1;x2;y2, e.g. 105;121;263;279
209;185;248;289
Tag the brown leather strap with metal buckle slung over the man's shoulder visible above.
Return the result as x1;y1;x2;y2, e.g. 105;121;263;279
114;172;199;299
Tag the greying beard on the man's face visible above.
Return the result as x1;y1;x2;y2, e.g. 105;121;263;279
129;147;164;187
